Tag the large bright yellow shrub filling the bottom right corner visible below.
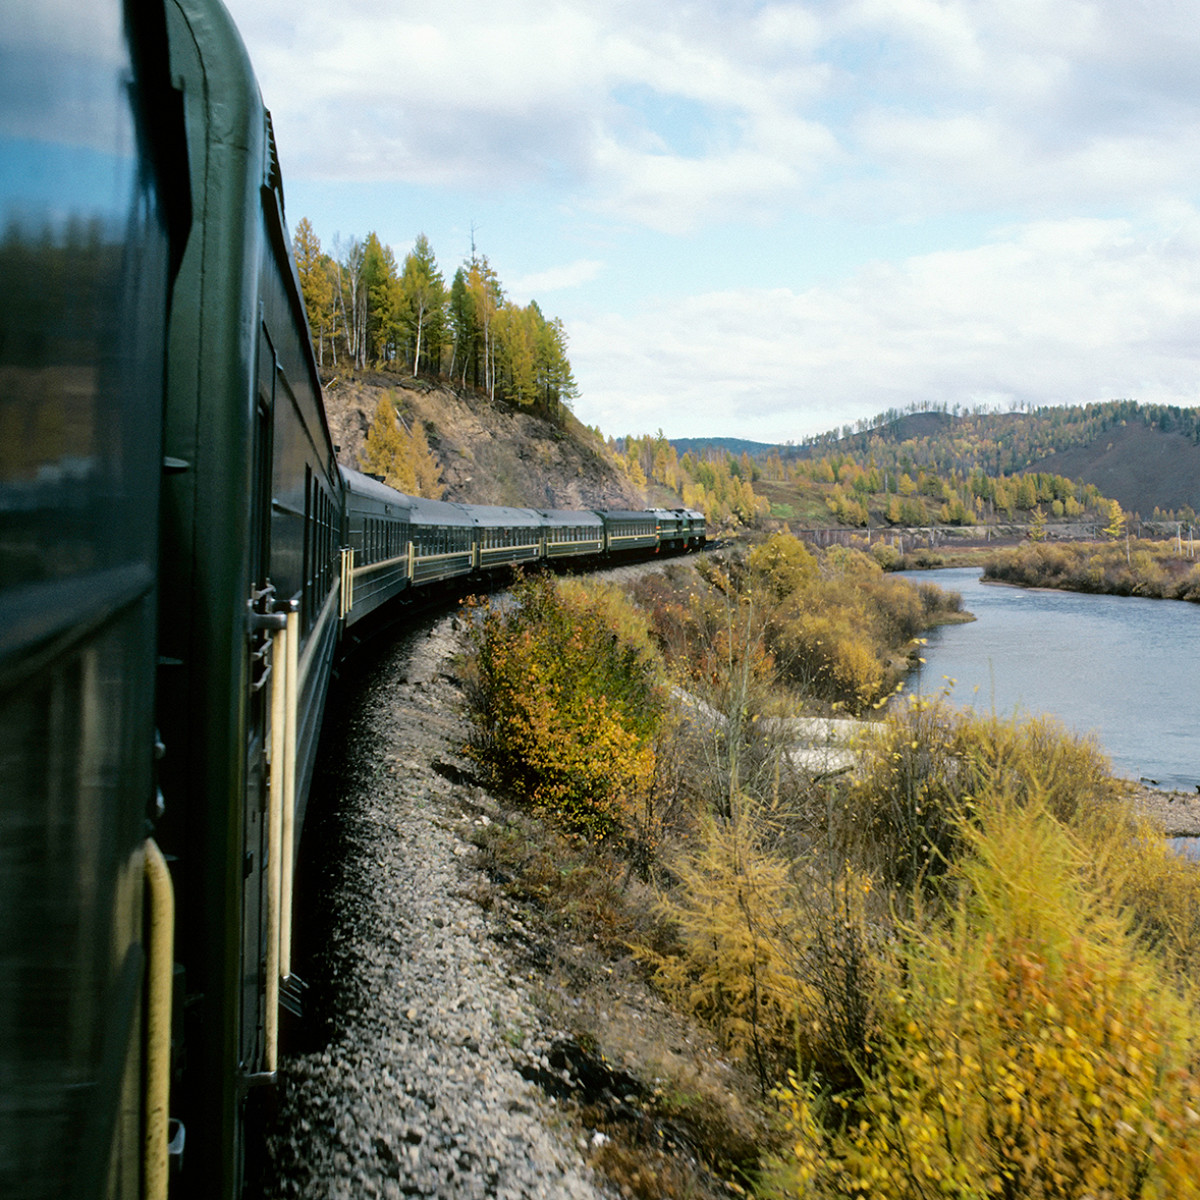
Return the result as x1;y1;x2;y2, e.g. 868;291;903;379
764;791;1200;1200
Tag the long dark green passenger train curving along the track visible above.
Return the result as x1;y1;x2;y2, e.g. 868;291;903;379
0;0;706;1200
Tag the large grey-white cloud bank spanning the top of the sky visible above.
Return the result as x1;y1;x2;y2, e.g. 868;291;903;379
225;0;1200;229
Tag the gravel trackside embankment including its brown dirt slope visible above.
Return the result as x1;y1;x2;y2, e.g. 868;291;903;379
259;604;761;1200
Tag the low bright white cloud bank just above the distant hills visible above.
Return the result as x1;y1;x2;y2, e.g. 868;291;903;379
571;211;1200;440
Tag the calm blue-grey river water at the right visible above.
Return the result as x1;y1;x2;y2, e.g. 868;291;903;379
905;568;1200;792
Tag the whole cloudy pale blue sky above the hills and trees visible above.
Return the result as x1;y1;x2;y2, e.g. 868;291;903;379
220;0;1200;442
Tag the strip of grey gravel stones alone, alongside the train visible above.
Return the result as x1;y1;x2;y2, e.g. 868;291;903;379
263;618;610;1200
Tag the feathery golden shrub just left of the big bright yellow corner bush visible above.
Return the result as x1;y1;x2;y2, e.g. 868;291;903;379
638;797;877;1094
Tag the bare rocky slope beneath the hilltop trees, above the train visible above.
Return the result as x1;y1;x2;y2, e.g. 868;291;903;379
325;373;647;509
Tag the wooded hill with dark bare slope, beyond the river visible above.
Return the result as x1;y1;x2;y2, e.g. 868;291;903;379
715;400;1200;527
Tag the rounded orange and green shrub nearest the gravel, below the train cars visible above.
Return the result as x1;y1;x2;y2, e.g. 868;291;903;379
468;577;666;840
